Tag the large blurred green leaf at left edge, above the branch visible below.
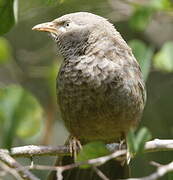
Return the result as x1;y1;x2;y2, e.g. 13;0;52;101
0;85;43;148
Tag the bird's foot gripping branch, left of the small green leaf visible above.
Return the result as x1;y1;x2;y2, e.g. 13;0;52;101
69;136;82;160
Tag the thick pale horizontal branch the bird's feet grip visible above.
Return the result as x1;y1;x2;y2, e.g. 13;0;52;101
0;139;173;157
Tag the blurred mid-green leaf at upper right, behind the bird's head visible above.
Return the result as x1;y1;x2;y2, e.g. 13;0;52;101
129;6;154;31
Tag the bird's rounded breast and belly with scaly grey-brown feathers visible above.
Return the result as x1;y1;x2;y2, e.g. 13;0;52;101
57;56;144;140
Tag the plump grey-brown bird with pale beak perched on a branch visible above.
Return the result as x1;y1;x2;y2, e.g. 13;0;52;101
32;12;146;180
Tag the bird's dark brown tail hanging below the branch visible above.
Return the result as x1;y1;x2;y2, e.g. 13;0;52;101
48;156;129;180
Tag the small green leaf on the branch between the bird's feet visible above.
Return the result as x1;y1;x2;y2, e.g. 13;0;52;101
76;141;110;168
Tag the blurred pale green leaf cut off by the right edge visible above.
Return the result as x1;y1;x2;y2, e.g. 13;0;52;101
153;42;173;72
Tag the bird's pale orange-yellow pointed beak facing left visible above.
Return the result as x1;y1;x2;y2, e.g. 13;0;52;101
32;22;57;34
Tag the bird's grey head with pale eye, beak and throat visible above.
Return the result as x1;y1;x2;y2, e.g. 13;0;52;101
32;12;116;56
